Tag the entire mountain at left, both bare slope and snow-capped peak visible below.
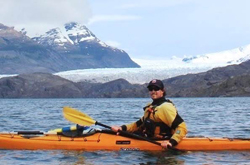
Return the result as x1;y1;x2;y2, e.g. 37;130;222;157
0;24;139;74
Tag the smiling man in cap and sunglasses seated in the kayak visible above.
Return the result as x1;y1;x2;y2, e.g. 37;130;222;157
111;79;187;148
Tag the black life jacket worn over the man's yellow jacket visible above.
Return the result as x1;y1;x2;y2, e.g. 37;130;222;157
142;99;183;139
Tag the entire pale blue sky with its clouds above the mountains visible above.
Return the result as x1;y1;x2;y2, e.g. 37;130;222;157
0;0;250;60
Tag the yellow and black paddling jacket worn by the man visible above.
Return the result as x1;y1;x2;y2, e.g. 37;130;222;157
122;98;187;146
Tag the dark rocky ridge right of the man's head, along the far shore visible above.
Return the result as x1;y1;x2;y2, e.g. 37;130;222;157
164;60;250;97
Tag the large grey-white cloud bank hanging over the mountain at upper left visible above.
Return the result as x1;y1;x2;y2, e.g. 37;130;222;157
0;0;92;36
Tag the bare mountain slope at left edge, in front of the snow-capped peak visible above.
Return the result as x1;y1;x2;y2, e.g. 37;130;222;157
0;24;71;74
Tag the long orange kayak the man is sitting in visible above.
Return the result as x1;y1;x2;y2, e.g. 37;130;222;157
0;131;250;151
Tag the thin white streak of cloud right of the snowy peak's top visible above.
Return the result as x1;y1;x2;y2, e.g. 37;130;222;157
88;15;141;25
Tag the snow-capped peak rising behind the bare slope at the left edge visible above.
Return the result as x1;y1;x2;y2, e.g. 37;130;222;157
33;22;139;69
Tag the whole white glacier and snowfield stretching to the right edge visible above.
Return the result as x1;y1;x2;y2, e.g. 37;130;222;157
56;45;250;84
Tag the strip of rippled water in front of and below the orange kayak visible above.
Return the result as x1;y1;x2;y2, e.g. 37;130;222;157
0;146;250;165
